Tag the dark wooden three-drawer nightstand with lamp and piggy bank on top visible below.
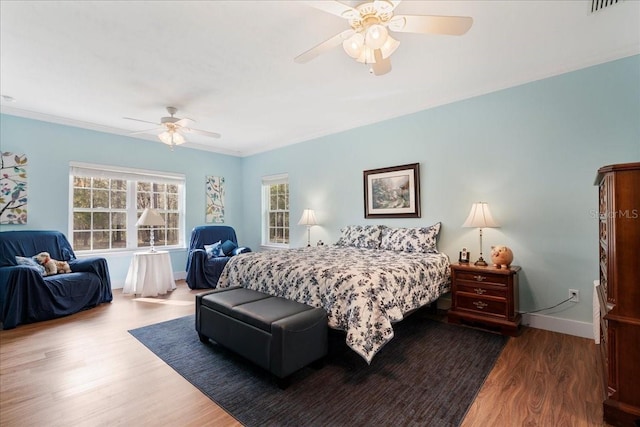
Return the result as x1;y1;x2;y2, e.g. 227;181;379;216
448;264;522;336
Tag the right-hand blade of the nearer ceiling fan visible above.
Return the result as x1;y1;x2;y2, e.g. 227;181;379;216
388;15;473;36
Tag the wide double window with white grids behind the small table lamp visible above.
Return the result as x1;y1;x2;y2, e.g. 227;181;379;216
69;163;184;252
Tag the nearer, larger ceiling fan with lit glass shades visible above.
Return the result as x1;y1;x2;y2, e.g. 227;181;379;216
294;0;473;76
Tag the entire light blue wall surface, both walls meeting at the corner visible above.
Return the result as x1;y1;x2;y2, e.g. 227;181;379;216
0;56;640;322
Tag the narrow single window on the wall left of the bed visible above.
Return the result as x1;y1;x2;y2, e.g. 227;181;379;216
262;174;289;247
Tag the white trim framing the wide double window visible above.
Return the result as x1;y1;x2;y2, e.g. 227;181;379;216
67;161;187;254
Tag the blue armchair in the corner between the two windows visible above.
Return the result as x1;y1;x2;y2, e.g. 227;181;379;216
187;225;251;289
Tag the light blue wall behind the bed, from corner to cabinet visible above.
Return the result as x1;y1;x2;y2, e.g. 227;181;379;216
242;56;640;322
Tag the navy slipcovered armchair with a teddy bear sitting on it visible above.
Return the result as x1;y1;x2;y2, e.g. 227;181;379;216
0;230;113;329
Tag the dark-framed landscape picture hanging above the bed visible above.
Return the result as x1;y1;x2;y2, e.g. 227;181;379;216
363;163;420;218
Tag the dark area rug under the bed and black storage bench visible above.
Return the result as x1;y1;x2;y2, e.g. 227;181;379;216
129;310;507;427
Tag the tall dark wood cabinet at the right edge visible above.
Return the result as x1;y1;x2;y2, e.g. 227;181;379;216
595;163;640;426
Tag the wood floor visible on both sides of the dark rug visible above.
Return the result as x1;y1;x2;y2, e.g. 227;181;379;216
0;282;603;427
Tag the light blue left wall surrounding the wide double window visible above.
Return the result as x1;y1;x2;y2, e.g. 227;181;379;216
0;115;244;287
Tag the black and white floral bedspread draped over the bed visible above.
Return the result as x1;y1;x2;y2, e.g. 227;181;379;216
218;246;450;363
